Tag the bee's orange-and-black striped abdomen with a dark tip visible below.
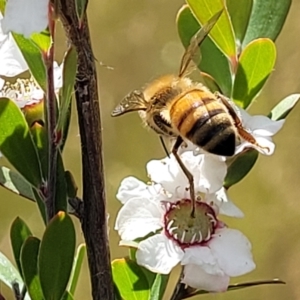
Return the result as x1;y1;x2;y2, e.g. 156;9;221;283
170;90;237;156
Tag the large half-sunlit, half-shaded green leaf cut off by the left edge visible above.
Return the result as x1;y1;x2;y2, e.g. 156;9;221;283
0;98;42;187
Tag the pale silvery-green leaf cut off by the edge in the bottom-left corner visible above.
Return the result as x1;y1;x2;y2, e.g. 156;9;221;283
0;252;23;289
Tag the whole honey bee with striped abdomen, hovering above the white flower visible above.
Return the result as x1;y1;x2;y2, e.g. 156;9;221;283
112;11;262;216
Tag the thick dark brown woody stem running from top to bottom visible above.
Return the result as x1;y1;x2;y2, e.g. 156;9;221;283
58;0;113;300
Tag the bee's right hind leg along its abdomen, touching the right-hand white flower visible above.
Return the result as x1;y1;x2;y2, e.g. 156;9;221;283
215;92;270;152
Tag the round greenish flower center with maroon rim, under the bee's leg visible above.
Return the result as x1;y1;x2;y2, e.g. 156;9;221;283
164;199;218;247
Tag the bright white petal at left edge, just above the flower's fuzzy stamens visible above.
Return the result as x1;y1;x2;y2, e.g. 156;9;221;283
0;12;28;79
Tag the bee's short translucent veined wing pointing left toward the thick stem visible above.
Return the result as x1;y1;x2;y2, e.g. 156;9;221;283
111;90;147;117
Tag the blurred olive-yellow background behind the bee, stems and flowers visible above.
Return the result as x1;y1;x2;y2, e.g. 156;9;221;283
0;0;300;300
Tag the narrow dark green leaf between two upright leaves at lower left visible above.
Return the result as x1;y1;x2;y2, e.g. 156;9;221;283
21;236;44;300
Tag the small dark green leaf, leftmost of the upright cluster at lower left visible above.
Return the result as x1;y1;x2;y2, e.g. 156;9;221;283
10;217;32;275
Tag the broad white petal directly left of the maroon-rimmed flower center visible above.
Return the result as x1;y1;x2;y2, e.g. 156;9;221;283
115;198;163;240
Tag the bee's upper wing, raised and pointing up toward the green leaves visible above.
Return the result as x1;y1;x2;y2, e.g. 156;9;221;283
179;9;223;77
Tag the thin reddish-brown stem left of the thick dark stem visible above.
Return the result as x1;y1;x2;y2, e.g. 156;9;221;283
44;5;57;223
